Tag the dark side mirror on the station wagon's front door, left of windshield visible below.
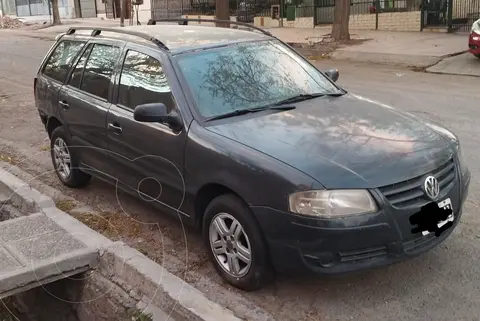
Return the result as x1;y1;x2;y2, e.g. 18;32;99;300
133;103;182;130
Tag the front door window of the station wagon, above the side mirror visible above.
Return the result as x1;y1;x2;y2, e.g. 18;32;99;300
118;50;175;112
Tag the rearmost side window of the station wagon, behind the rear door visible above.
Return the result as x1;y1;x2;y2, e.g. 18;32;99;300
43;40;85;83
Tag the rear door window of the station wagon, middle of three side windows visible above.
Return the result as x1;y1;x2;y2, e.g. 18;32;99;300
80;44;120;99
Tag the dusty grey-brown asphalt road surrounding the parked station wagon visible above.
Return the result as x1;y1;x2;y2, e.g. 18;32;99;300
0;32;480;321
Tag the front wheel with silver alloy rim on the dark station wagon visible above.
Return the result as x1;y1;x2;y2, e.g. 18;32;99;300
202;194;272;291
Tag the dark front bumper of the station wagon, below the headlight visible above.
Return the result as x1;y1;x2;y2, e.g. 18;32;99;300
252;168;470;275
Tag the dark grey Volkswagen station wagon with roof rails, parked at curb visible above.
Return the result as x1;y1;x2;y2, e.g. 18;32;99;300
35;20;470;290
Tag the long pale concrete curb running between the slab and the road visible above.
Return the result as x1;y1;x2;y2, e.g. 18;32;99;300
0;168;241;321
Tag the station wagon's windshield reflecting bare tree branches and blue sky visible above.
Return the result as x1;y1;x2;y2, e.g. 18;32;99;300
177;40;340;118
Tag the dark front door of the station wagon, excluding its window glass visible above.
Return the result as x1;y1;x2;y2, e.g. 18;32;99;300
107;43;192;217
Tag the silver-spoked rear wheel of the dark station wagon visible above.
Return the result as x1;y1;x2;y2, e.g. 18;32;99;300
50;126;92;188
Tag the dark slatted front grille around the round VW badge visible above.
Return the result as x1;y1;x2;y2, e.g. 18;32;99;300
379;158;455;208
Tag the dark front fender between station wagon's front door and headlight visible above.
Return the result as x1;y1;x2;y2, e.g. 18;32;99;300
182;121;323;220
